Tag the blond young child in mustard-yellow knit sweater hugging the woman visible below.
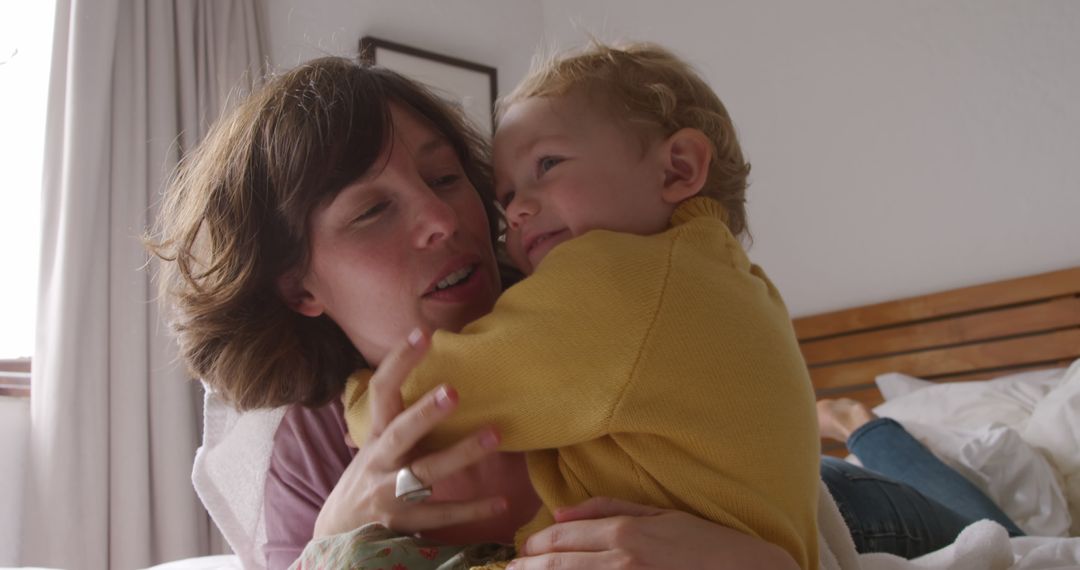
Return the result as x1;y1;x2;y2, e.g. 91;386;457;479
345;44;819;568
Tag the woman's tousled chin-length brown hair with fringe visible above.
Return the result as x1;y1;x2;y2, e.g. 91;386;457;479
146;57;497;409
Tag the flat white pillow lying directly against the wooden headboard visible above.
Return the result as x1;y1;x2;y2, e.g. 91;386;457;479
875;368;1065;430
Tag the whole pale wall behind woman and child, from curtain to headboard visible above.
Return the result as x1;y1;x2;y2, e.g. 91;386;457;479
267;0;1080;315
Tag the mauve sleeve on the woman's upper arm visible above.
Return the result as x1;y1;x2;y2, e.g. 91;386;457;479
264;398;356;570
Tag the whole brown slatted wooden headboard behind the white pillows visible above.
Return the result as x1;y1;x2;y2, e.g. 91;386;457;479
795;267;1080;452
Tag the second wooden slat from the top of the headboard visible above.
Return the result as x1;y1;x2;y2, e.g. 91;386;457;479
801;297;1080;366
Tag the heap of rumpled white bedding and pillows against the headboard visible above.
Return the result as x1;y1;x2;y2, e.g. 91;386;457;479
874;361;1080;537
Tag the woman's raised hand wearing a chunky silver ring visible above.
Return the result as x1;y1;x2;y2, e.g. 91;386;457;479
314;330;507;539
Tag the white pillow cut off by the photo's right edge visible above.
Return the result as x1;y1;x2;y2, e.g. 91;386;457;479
1023;361;1080;535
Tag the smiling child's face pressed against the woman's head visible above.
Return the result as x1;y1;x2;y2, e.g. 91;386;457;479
495;92;675;274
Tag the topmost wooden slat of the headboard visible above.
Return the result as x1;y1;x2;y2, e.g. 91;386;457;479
795;268;1080;340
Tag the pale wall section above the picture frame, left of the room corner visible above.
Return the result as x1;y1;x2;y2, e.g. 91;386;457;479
262;0;543;96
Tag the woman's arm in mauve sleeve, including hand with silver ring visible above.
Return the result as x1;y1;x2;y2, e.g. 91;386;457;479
265;332;535;569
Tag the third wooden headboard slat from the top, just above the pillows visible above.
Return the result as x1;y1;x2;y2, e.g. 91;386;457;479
810;328;1080;391
